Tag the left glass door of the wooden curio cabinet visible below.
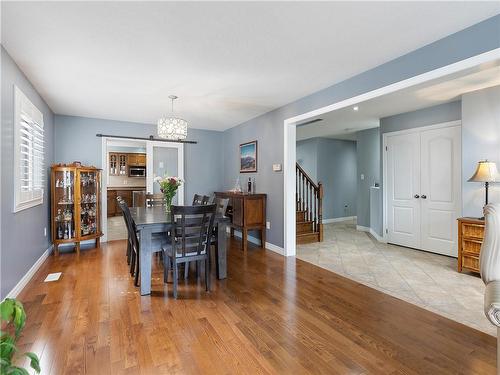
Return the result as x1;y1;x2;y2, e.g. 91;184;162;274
54;170;76;240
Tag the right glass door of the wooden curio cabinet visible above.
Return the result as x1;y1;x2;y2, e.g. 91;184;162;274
80;171;99;237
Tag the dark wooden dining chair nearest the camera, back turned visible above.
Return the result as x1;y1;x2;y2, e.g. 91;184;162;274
163;204;216;298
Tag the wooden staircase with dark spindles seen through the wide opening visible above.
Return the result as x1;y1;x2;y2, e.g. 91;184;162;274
295;164;323;244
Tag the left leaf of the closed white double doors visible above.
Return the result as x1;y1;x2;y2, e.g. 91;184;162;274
386;133;420;248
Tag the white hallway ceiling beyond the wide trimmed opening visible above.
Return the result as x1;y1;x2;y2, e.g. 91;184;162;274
297;60;500;140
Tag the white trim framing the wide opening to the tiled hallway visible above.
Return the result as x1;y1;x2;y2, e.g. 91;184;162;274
283;48;500;256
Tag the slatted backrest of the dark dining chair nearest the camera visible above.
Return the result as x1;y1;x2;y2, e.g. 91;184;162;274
171;204;216;257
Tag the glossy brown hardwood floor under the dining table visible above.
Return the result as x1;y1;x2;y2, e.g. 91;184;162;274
16;240;496;374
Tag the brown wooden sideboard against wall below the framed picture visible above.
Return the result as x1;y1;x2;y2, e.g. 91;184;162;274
215;192;267;251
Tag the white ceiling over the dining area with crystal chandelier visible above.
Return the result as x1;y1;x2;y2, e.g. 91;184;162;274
1;1;500;130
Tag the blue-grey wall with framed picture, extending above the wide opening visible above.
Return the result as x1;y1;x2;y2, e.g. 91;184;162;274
224;15;500;250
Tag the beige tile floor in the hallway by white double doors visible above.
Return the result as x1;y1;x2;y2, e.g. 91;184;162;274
297;221;496;336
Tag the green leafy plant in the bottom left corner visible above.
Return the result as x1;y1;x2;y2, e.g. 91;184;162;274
0;298;40;375
